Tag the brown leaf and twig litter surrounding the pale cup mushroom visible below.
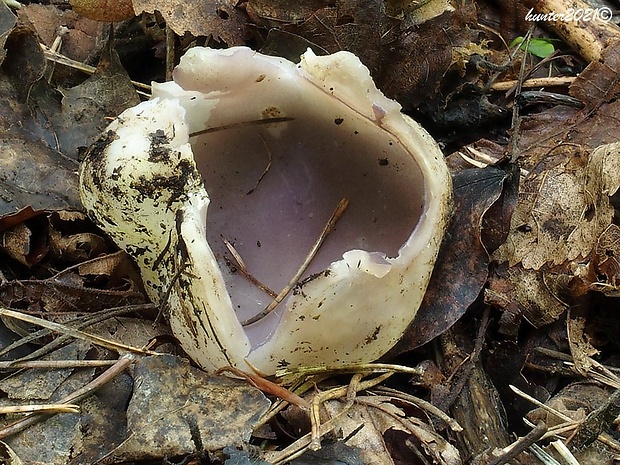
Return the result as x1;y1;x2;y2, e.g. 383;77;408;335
0;0;620;464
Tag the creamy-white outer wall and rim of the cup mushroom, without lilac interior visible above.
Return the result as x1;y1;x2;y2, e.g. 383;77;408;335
80;47;451;374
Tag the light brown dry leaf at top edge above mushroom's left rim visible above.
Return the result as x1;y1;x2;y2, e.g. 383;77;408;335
133;0;247;46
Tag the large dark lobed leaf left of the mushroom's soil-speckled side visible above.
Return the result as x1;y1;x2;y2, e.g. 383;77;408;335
0;24;137;216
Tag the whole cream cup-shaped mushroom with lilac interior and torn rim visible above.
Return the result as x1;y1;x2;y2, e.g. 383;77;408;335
80;47;451;374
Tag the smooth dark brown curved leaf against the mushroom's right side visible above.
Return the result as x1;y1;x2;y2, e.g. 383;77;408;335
387;167;516;352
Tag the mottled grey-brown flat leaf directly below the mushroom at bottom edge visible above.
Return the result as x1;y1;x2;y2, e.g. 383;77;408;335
98;355;269;464
